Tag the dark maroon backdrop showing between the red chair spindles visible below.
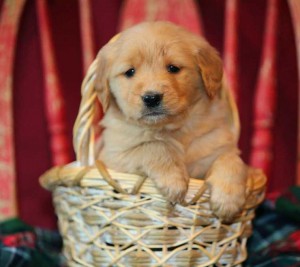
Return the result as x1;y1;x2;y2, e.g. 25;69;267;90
0;0;298;227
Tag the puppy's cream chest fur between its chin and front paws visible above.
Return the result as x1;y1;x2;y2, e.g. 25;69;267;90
100;96;234;178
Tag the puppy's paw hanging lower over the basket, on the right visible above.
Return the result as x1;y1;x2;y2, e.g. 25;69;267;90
210;184;246;222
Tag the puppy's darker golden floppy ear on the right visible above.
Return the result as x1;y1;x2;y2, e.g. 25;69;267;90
196;40;223;98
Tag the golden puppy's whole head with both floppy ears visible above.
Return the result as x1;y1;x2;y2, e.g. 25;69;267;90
96;22;222;125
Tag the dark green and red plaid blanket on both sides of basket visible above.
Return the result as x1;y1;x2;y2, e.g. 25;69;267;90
0;187;300;267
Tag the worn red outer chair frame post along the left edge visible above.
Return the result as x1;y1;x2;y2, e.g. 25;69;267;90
0;0;25;221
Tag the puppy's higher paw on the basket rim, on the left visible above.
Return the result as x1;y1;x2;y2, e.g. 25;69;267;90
156;175;188;203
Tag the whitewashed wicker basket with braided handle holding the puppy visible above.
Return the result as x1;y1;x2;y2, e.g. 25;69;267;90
40;57;266;267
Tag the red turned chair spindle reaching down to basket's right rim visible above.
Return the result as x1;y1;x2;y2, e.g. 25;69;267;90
250;0;278;180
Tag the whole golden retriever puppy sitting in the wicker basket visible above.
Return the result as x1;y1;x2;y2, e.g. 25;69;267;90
96;22;247;222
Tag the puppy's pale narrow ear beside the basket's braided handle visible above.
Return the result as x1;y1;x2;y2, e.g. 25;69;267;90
95;46;111;112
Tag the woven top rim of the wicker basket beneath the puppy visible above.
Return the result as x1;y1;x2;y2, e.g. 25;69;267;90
39;161;267;208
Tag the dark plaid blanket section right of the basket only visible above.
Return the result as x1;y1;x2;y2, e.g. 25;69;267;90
244;187;300;267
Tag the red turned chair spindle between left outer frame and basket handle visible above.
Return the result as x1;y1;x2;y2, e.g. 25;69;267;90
36;0;71;165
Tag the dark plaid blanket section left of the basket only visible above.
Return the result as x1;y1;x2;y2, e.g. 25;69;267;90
0;219;63;267
